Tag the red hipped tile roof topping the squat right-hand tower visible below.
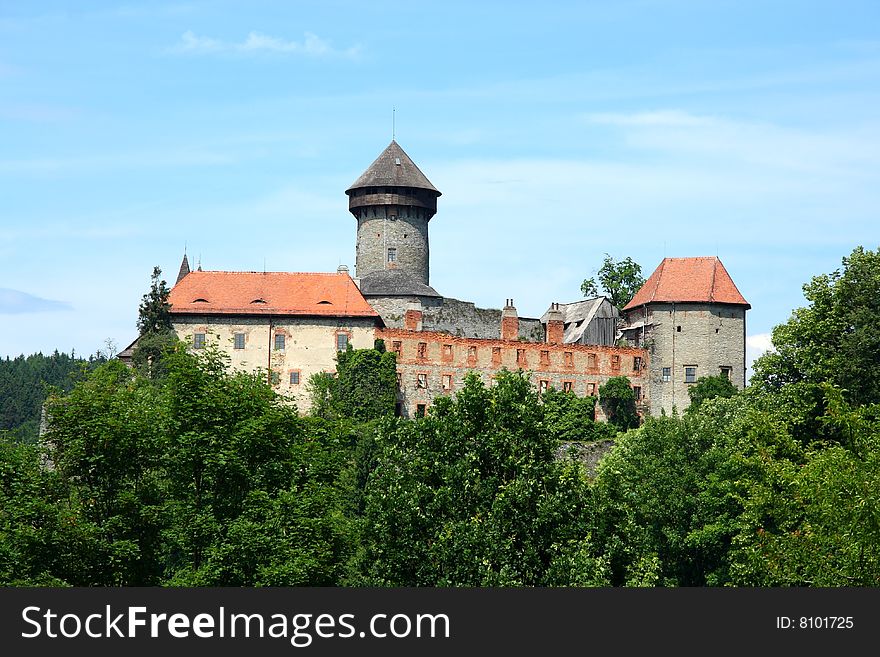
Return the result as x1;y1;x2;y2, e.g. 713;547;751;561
624;257;751;310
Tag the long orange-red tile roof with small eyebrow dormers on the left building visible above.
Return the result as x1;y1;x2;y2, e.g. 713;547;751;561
168;271;379;317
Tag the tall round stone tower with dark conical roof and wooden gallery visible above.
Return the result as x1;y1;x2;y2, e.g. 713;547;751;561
345;140;440;285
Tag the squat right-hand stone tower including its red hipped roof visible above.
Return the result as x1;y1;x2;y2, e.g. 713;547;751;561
622;257;751;415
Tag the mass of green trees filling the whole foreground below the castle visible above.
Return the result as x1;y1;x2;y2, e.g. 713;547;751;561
0;248;880;587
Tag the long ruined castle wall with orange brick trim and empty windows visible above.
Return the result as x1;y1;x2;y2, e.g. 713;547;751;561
376;328;650;419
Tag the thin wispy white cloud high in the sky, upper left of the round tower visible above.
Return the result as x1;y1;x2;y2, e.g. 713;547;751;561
168;30;360;59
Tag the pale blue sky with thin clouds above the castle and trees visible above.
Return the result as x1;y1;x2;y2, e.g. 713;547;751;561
0;0;880;376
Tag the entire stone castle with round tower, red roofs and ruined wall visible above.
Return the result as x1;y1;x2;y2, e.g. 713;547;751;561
155;141;750;417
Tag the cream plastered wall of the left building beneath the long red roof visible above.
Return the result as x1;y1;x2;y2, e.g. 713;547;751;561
172;315;375;412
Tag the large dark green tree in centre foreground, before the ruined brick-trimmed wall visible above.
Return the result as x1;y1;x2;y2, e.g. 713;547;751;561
358;372;604;586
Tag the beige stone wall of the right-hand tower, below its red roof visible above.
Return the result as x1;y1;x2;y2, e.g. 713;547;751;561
625;303;746;415
